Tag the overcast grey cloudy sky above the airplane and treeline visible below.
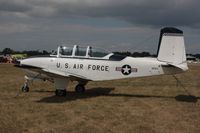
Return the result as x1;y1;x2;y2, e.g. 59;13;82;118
0;0;200;53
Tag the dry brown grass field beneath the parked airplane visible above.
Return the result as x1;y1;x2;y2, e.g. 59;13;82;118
0;64;200;133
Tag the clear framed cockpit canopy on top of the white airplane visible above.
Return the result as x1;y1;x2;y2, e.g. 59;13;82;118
50;45;113;59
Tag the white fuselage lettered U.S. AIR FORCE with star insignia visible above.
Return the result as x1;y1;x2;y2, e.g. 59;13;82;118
20;57;181;81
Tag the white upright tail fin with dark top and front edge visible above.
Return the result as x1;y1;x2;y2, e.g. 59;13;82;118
157;27;188;70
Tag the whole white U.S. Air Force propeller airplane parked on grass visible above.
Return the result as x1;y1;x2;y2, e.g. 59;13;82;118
16;27;188;96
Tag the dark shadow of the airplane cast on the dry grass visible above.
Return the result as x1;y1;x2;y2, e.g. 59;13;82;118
35;88;200;103
